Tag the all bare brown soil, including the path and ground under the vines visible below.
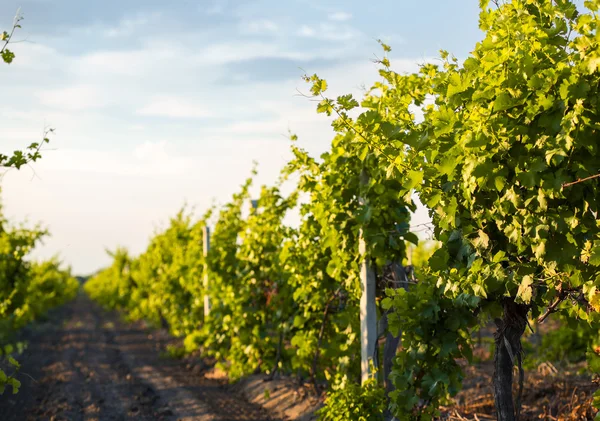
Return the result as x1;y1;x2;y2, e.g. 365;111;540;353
0;295;598;421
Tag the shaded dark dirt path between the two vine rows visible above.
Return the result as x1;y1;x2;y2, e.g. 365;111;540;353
0;296;272;421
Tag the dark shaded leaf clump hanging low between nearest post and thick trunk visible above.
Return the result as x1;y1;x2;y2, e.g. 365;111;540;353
382;279;480;419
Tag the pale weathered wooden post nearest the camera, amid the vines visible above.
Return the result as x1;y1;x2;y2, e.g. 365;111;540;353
358;170;377;383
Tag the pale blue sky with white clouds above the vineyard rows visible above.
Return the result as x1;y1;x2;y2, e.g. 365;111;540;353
0;0;482;274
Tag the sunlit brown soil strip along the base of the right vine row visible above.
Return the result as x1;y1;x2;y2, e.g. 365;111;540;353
113;314;597;421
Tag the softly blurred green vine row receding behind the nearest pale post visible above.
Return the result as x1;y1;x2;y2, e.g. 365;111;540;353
86;134;410;381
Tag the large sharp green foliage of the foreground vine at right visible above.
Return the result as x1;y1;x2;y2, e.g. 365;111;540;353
296;0;600;414
